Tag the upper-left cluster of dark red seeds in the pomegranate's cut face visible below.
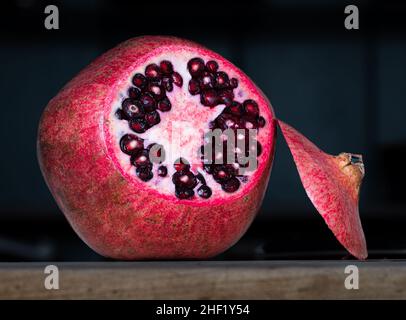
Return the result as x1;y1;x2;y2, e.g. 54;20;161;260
116;60;183;133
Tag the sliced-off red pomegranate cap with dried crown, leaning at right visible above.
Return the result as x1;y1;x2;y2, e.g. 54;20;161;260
278;120;368;259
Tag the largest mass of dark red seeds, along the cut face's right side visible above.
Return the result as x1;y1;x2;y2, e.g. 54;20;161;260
188;58;265;192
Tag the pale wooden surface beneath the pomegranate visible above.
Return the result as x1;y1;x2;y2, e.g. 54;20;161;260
0;261;406;299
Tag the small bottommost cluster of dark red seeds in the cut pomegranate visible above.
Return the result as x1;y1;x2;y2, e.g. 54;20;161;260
172;158;212;199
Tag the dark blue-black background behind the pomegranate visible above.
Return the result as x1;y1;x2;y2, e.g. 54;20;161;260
0;0;406;261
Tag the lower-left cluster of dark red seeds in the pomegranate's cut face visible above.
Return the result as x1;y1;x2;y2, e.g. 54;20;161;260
120;134;168;181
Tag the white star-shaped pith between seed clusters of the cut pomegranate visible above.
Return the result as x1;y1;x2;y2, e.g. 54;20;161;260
109;51;269;201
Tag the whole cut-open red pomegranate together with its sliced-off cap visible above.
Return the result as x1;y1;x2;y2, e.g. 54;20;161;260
38;36;366;260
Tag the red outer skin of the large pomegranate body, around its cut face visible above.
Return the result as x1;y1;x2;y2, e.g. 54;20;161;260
37;36;276;260
